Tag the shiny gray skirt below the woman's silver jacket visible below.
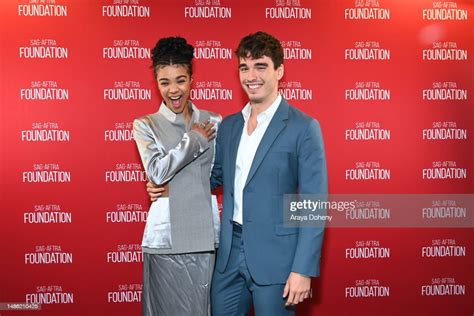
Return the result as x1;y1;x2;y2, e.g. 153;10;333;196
142;252;215;316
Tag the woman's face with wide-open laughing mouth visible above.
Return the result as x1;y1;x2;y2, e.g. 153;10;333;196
156;65;191;113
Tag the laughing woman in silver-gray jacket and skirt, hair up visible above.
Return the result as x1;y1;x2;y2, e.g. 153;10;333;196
134;37;221;316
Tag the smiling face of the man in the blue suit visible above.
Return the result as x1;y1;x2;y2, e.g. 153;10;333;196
239;56;284;105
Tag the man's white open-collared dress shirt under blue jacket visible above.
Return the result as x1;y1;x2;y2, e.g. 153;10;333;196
233;95;282;224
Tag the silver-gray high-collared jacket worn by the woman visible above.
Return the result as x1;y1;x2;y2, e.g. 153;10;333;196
133;103;222;254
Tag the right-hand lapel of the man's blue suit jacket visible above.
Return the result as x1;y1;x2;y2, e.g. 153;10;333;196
245;99;289;186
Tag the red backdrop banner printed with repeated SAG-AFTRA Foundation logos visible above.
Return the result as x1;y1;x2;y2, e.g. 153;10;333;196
0;0;474;316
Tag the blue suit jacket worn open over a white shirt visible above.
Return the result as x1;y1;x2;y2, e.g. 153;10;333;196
211;100;327;285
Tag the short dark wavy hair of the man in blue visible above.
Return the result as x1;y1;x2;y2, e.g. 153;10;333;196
235;32;283;69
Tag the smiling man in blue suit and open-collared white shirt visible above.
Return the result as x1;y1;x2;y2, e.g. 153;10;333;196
149;32;327;316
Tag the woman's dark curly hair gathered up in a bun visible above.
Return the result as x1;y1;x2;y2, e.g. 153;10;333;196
151;37;194;76
